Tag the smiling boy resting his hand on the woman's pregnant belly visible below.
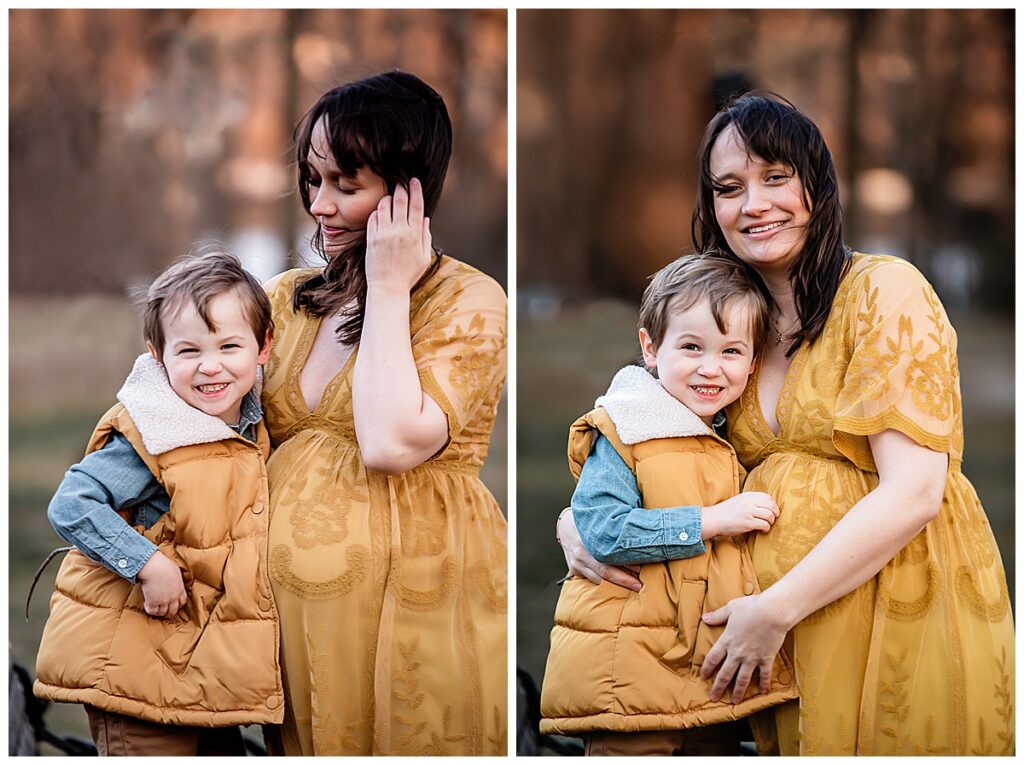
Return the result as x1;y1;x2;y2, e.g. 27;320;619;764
541;254;797;755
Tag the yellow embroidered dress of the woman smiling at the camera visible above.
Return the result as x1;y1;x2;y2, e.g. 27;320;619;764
729;255;1014;755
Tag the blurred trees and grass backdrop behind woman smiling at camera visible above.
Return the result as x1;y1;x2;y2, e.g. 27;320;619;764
516;10;1015;704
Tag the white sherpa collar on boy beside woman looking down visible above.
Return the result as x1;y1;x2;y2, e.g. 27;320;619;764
118;353;250;455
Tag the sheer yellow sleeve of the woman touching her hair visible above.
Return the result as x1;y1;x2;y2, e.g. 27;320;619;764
413;263;508;440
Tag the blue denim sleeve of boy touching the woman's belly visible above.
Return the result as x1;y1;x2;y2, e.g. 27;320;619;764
572;434;705;565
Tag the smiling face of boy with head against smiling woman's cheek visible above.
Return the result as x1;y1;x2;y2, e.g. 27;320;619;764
640;300;755;425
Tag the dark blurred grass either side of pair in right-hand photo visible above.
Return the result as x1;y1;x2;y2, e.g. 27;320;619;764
516;301;1015;696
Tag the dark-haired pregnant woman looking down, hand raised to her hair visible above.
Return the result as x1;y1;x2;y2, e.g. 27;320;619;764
262;72;507;755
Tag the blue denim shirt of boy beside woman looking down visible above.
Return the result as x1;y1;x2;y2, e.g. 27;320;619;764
46;391;263;582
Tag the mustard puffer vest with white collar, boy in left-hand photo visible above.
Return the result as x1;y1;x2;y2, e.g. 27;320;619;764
33;354;284;727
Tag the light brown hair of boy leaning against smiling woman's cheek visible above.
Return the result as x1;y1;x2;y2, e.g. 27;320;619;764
638;251;771;354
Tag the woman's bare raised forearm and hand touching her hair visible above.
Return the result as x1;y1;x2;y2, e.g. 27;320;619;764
352;178;449;473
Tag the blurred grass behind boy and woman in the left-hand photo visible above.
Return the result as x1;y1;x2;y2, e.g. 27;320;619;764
7;296;508;754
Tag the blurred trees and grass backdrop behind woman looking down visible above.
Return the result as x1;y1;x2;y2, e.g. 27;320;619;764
8;9;508;749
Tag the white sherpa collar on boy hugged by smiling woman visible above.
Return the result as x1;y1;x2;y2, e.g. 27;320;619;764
594;367;712;444
